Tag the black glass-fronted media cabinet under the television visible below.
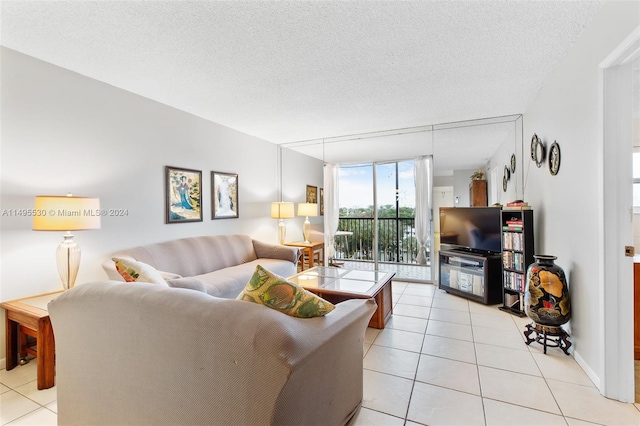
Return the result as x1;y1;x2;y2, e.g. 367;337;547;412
438;249;503;305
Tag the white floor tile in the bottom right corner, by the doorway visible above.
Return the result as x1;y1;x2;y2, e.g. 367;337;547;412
547;380;640;426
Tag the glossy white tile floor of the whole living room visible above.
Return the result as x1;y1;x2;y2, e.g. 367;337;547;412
0;282;640;426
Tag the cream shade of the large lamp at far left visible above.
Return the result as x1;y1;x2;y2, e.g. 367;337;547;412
33;195;100;231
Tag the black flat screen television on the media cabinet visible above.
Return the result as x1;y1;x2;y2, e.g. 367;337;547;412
440;207;502;254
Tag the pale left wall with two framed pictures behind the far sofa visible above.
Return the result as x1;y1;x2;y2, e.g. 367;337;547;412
0;48;322;359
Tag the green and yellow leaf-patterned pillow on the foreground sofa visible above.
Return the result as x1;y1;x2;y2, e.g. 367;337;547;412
236;265;335;318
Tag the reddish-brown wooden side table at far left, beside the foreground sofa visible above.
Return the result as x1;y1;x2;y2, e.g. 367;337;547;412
0;291;62;390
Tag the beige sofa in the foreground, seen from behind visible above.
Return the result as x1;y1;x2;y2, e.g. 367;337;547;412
49;282;376;426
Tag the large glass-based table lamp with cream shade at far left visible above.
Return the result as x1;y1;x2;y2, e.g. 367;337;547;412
33;194;100;290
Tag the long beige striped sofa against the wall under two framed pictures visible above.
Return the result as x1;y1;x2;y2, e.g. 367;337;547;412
103;235;299;298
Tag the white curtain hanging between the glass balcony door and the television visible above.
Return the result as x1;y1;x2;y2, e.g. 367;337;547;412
413;156;433;265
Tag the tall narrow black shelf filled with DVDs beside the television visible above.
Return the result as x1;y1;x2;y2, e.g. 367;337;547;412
500;206;534;317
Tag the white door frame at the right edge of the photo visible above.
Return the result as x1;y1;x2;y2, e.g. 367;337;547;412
599;27;640;402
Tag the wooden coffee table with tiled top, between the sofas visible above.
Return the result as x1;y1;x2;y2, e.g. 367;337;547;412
289;266;395;329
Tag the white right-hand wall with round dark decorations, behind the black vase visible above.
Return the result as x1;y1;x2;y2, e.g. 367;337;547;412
524;2;640;390
